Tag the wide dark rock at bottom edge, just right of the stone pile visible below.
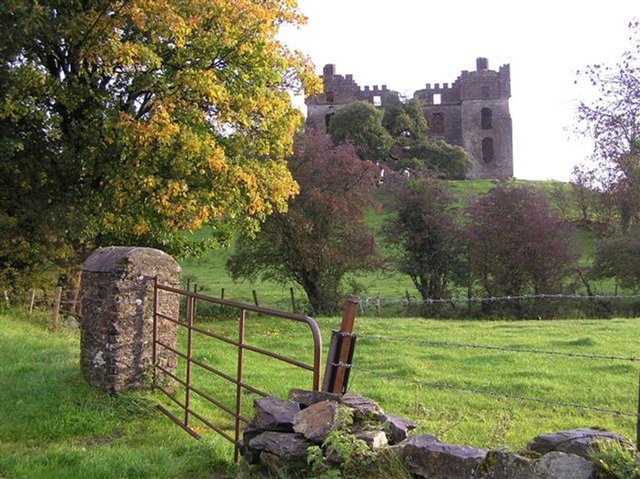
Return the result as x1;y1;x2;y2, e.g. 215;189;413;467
394;436;487;479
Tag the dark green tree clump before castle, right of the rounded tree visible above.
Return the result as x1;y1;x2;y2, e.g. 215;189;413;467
382;94;472;180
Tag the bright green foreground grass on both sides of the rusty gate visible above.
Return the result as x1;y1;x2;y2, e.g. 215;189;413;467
0;311;639;479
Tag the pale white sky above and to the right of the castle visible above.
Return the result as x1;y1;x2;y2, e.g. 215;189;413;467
281;0;640;181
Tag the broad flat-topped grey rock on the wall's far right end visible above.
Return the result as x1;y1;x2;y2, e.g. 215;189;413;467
527;428;633;459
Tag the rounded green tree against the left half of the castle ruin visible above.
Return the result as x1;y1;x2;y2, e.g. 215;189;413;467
328;101;393;162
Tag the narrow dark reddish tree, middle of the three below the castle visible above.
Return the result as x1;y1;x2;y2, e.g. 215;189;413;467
382;177;461;300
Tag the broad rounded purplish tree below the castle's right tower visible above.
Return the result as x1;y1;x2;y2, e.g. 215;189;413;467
467;182;576;297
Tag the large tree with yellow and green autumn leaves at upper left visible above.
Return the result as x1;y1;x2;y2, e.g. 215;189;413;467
0;0;317;294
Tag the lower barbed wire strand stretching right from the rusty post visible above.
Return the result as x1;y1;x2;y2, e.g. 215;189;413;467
351;365;640;419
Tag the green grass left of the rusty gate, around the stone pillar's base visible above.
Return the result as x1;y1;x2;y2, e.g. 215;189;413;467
0;310;235;479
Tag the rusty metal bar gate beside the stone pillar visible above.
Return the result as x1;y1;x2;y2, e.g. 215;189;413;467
153;282;332;461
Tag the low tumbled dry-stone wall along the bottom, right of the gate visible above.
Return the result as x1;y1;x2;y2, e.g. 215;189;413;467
241;390;633;479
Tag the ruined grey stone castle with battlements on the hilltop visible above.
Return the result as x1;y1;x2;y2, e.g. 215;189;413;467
305;58;513;179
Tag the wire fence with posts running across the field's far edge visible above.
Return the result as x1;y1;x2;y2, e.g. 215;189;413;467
8;280;640;319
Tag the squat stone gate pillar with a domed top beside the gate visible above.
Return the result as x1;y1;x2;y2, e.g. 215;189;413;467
80;246;181;394
